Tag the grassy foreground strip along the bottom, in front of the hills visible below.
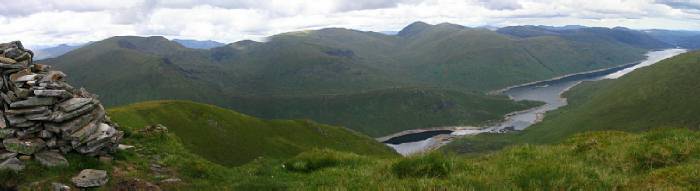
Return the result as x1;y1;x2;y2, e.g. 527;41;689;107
5;103;700;190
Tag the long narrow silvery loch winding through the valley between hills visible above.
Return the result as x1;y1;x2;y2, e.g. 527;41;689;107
384;49;686;155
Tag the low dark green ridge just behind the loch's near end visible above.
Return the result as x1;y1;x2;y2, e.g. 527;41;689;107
230;88;539;137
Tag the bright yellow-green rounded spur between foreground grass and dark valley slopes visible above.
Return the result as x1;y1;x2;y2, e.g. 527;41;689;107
109;101;395;166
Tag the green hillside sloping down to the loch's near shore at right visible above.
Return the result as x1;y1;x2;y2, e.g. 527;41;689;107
447;52;700;152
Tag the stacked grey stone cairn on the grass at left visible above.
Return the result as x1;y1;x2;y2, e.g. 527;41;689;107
0;41;124;171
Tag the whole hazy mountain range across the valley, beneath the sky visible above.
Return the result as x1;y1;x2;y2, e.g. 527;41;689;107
44;22;647;135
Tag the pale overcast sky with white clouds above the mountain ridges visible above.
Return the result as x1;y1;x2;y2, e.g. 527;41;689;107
0;0;700;48
